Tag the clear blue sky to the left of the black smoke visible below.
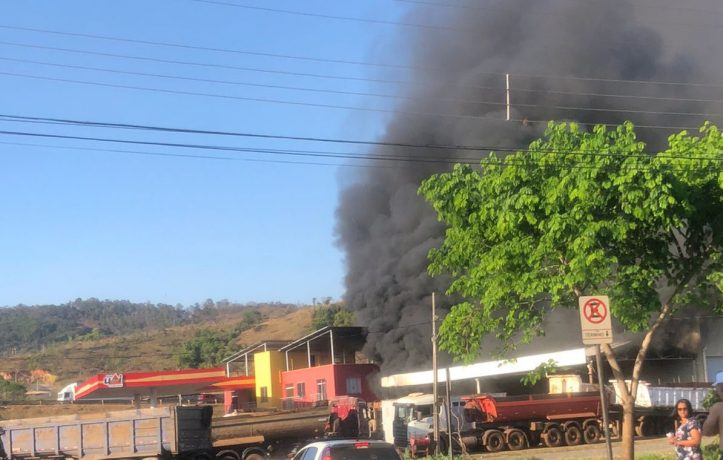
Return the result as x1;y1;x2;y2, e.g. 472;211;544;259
0;0;413;306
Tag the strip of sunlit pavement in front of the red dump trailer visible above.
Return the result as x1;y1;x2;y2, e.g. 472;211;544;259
464;438;673;460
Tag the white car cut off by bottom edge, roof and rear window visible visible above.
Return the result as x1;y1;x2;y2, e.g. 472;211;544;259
292;439;403;460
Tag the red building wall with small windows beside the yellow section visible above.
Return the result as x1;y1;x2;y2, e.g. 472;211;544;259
281;364;379;405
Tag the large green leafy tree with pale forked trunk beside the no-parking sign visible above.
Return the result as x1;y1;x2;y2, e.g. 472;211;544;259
420;122;723;459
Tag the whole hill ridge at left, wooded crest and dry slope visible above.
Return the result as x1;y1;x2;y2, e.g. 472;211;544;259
0;299;314;385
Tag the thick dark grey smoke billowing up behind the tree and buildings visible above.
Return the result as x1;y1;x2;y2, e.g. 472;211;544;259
337;0;723;371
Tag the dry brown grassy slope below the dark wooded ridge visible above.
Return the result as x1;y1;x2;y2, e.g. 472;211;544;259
0;306;313;389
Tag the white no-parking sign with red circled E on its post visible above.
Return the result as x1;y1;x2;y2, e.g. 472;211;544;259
579;295;613;460
